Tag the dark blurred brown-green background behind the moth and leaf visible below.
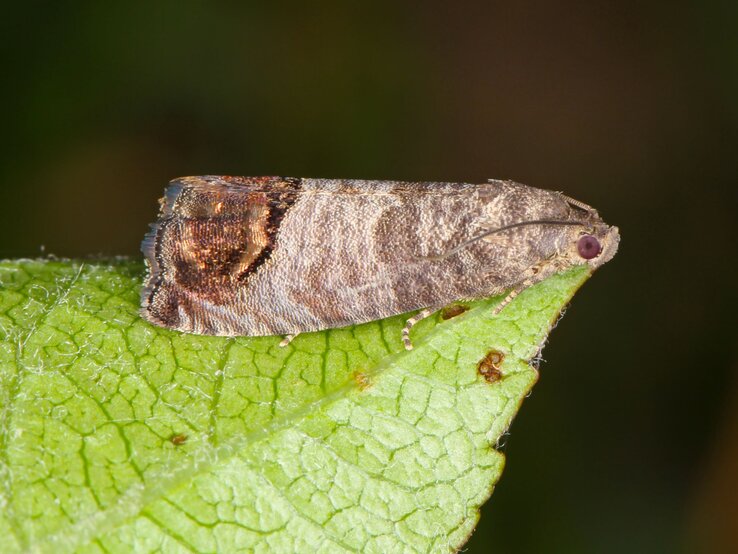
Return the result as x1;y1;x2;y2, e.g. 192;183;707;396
0;0;738;554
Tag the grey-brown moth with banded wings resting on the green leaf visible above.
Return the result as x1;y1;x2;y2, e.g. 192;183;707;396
141;176;619;348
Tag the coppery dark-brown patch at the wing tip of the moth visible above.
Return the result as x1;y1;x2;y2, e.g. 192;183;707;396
142;177;300;328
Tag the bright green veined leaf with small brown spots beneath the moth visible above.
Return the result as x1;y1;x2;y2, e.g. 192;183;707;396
0;260;589;553
